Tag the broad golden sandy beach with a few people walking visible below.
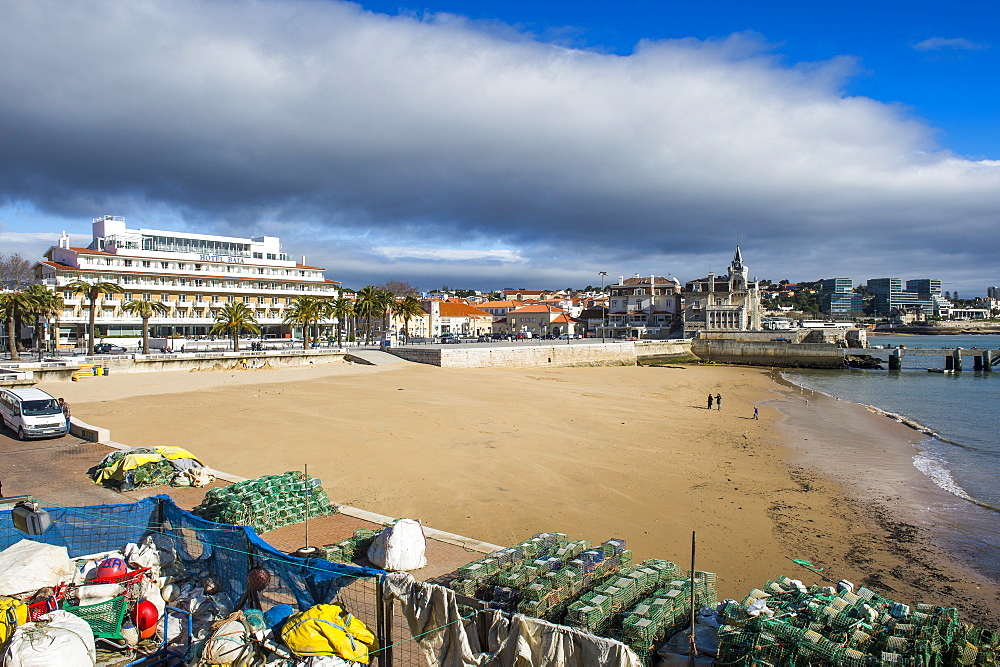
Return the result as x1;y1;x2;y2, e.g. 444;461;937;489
40;363;1000;626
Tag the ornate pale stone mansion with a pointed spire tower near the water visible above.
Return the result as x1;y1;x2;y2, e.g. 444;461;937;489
682;246;762;338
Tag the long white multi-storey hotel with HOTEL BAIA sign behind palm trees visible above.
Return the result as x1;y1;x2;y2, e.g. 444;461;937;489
35;215;340;344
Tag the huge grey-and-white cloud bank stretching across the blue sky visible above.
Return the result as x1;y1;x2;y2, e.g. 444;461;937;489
0;0;1000;290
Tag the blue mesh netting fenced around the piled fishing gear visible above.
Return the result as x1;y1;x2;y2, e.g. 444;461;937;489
0;496;385;609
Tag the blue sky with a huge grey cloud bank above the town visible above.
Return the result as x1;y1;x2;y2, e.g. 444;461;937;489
0;0;1000;297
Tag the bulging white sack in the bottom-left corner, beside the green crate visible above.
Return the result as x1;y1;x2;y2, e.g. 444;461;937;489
4;610;97;667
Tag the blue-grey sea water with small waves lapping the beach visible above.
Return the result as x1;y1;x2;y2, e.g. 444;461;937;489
784;335;1000;581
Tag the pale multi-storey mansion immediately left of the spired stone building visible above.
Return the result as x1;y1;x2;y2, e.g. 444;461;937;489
607;275;681;339
